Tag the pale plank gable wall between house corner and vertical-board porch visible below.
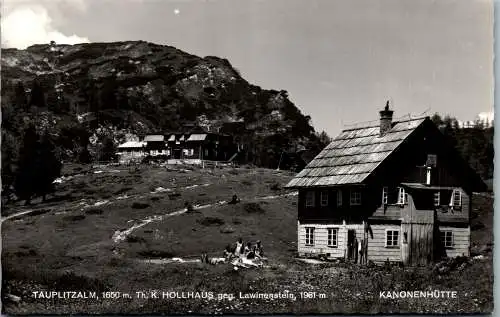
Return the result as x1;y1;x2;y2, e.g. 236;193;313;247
367;224;402;263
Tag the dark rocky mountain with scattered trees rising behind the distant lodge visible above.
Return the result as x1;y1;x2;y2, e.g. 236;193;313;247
1;41;321;167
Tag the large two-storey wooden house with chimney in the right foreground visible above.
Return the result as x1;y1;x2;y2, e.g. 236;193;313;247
286;103;486;265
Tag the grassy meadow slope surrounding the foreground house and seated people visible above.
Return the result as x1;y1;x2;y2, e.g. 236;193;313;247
2;166;493;314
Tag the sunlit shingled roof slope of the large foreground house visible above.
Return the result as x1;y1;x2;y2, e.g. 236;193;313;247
286;117;428;188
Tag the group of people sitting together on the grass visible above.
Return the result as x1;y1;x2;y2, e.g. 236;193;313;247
201;238;265;267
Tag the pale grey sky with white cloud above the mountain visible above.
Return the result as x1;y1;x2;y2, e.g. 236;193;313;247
2;0;493;136
